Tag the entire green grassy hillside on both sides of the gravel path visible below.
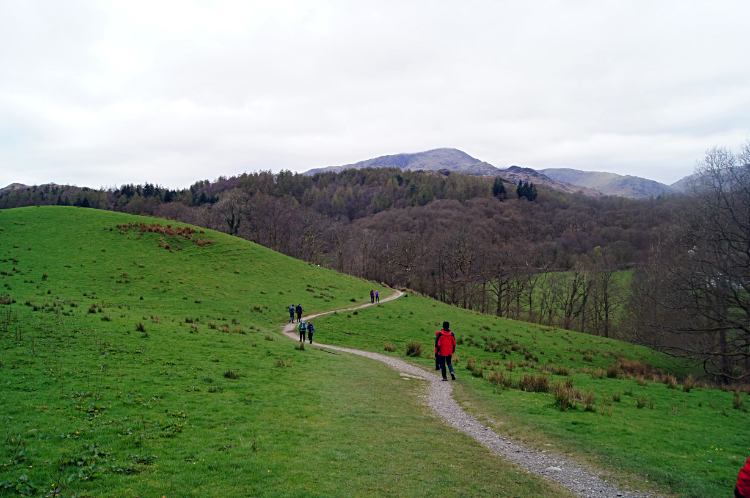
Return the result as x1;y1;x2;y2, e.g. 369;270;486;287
0;206;748;498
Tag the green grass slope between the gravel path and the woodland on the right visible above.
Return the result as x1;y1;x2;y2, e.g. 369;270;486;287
312;295;750;497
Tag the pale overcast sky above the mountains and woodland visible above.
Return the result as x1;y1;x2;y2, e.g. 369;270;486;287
0;0;750;188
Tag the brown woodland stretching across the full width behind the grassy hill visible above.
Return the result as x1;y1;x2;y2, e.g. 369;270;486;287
0;142;750;382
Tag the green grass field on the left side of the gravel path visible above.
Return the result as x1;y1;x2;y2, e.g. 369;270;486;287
0;207;580;497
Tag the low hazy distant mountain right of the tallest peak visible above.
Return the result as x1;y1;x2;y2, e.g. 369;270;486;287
539;168;682;199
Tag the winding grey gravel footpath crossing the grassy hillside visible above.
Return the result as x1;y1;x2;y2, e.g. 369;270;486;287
283;291;654;498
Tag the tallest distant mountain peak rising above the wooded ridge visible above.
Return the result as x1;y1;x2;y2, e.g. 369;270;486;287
304;149;500;176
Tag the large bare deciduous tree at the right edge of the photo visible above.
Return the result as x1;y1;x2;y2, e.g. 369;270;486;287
636;141;750;380
